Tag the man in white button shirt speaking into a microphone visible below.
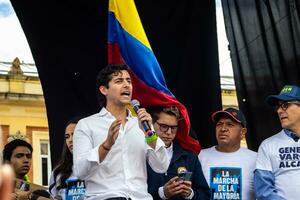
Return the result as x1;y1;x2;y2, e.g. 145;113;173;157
73;65;169;200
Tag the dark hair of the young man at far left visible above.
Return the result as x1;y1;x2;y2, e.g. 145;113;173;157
3;139;33;162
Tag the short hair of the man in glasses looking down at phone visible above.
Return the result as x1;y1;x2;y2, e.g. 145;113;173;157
149;106;182;123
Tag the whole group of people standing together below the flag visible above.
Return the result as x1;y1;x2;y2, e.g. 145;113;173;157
0;65;300;200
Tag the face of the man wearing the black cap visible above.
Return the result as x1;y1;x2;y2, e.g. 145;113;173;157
216;116;246;148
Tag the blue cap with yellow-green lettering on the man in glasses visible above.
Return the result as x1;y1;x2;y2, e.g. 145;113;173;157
266;85;300;106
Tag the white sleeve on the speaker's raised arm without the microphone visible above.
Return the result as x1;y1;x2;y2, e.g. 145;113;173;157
73;121;100;180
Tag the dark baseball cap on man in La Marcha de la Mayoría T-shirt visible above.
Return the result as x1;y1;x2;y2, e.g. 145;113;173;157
211;108;247;127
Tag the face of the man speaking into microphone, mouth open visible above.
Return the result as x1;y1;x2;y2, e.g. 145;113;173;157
99;70;132;106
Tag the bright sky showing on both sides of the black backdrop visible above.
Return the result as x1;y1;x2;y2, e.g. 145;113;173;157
0;0;233;77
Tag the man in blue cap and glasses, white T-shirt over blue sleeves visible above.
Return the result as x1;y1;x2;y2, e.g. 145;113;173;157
254;85;300;200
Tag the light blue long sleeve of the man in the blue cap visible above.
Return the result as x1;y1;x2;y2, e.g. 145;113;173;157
254;169;284;200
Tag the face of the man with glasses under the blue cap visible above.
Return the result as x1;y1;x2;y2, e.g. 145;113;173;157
277;102;300;134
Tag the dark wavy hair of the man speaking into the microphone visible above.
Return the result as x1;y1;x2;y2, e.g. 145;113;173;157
96;64;129;107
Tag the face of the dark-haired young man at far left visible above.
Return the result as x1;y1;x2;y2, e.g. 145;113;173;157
10;146;32;178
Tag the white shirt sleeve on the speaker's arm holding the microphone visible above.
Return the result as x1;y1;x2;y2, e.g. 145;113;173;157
147;137;170;173
